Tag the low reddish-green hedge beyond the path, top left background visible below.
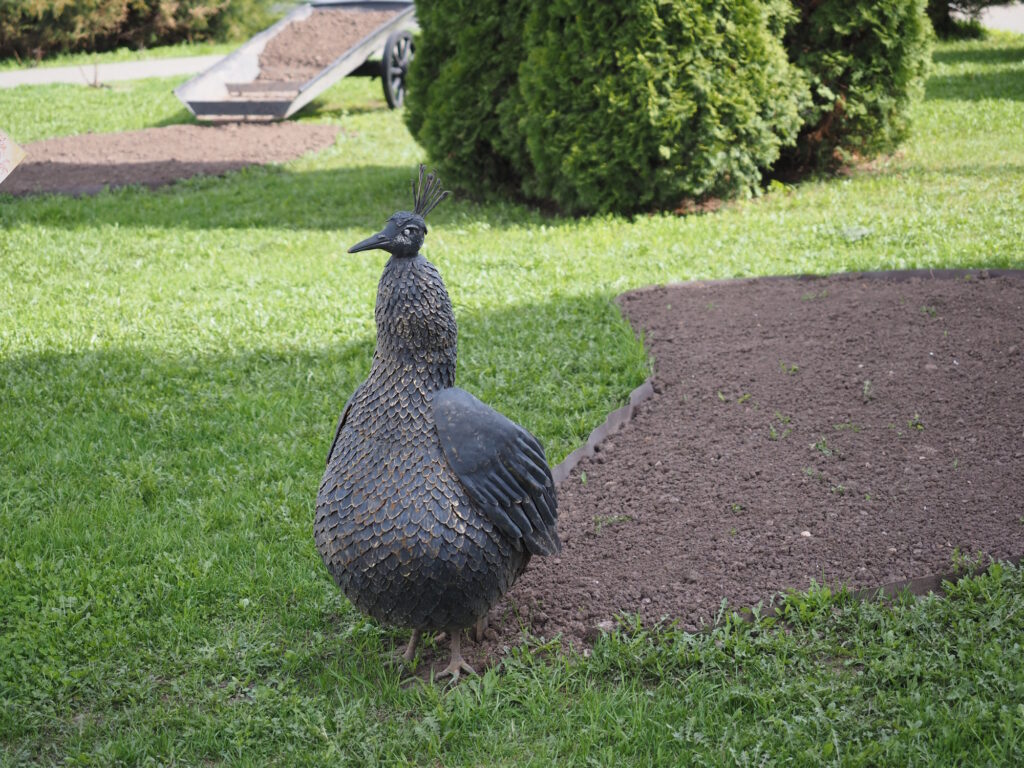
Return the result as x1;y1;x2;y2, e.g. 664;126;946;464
0;0;271;59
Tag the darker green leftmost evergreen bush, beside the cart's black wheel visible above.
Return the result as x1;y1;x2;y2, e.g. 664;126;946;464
406;0;529;196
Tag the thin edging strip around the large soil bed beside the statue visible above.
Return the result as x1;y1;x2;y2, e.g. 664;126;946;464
551;268;1024;644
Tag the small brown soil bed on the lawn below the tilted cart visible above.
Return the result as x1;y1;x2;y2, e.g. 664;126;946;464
0;123;338;195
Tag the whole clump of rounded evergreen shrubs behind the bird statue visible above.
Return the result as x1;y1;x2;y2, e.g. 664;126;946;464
406;0;932;213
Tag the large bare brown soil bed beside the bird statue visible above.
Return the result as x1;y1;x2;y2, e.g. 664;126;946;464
425;272;1024;666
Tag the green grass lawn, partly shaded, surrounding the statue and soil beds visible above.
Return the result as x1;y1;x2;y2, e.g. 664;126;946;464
0;35;1024;766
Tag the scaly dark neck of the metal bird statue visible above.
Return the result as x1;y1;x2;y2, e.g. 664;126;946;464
371;254;458;390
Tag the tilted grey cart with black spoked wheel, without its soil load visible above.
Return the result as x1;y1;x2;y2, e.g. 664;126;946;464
174;0;419;121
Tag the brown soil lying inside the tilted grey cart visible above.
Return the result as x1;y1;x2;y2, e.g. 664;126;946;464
256;8;398;86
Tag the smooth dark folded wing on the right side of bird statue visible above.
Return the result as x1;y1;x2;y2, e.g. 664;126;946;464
433;387;562;555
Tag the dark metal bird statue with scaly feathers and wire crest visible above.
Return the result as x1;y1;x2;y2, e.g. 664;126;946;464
313;166;561;679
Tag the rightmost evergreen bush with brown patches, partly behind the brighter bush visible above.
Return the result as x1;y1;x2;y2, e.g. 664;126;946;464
784;0;934;167
